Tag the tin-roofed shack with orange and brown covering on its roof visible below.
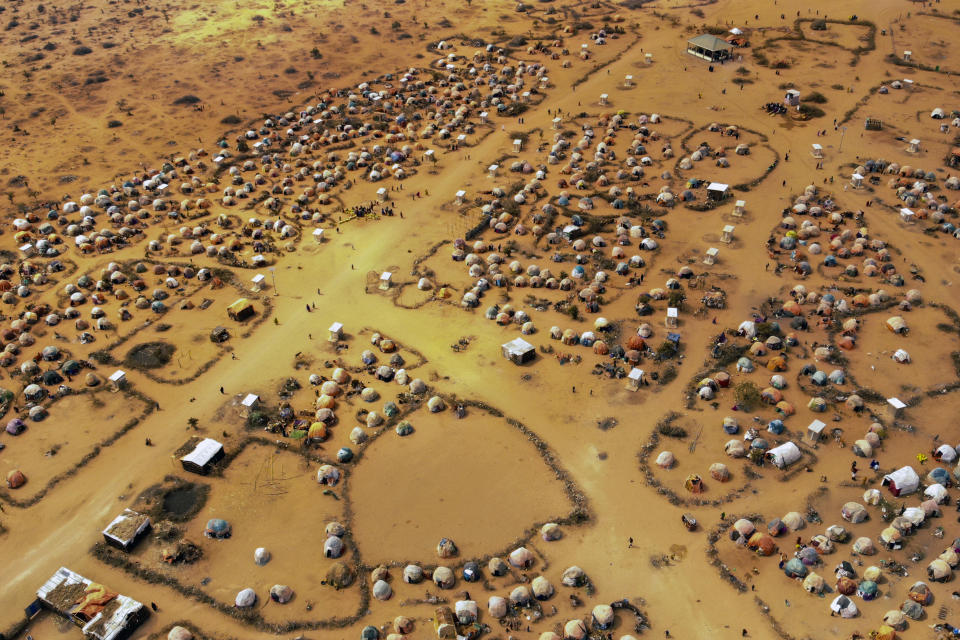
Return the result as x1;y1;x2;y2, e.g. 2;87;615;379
37;567;150;640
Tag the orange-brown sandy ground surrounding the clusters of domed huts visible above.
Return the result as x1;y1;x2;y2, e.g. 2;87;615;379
0;0;960;638
